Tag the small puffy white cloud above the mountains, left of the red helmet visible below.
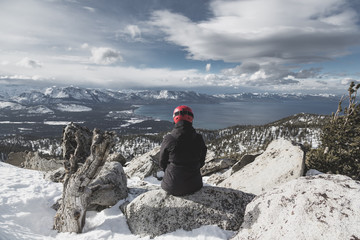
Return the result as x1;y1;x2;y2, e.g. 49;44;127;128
90;47;123;65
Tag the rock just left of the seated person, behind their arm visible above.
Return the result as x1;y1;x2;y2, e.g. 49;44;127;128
124;147;161;179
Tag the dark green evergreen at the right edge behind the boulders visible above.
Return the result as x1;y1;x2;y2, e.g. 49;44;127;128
307;82;360;180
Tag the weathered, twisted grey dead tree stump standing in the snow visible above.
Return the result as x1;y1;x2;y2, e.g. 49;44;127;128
54;124;114;233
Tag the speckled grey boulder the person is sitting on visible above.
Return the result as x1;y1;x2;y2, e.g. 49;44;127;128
125;186;255;237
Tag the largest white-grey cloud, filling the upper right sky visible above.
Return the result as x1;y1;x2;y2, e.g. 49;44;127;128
152;0;360;63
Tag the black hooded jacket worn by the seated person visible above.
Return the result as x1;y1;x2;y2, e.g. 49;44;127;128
160;121;207;196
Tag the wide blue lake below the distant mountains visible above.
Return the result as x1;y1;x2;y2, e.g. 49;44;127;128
135;100;338;129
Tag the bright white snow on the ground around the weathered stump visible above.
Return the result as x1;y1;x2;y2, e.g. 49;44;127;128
0;162;235;240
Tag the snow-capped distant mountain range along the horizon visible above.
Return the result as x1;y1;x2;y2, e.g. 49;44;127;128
0;87;338;108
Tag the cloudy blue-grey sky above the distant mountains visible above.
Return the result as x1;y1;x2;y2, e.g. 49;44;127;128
0;0;360;93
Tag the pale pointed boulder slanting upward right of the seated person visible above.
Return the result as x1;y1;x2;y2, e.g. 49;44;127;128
218;139;304;195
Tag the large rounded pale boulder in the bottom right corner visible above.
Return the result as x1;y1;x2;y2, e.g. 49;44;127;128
232;174;360;240
